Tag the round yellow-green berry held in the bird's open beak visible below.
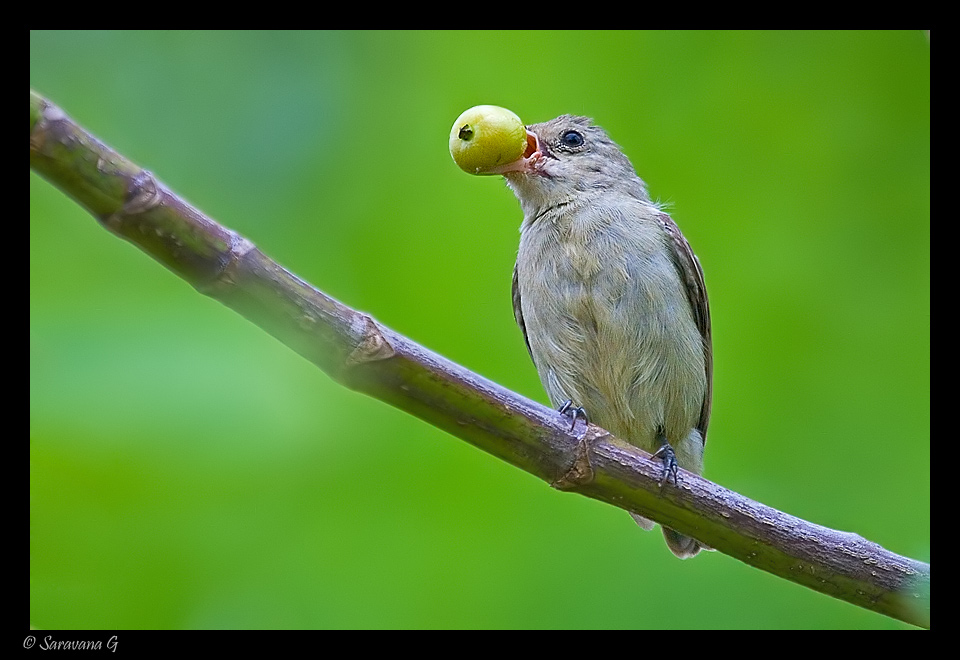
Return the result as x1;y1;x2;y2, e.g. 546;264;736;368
450;105;527;174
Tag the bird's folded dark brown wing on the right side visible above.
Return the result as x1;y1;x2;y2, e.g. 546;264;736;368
660;213;713;442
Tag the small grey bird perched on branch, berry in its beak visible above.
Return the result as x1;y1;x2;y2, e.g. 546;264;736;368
493;115;713;559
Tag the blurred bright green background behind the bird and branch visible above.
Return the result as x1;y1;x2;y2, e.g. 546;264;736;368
30;31;930;628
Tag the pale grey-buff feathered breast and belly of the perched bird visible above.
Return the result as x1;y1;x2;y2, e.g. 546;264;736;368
517;206;704;446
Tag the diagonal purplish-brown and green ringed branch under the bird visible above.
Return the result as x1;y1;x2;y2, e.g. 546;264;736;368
30;91;930;627
